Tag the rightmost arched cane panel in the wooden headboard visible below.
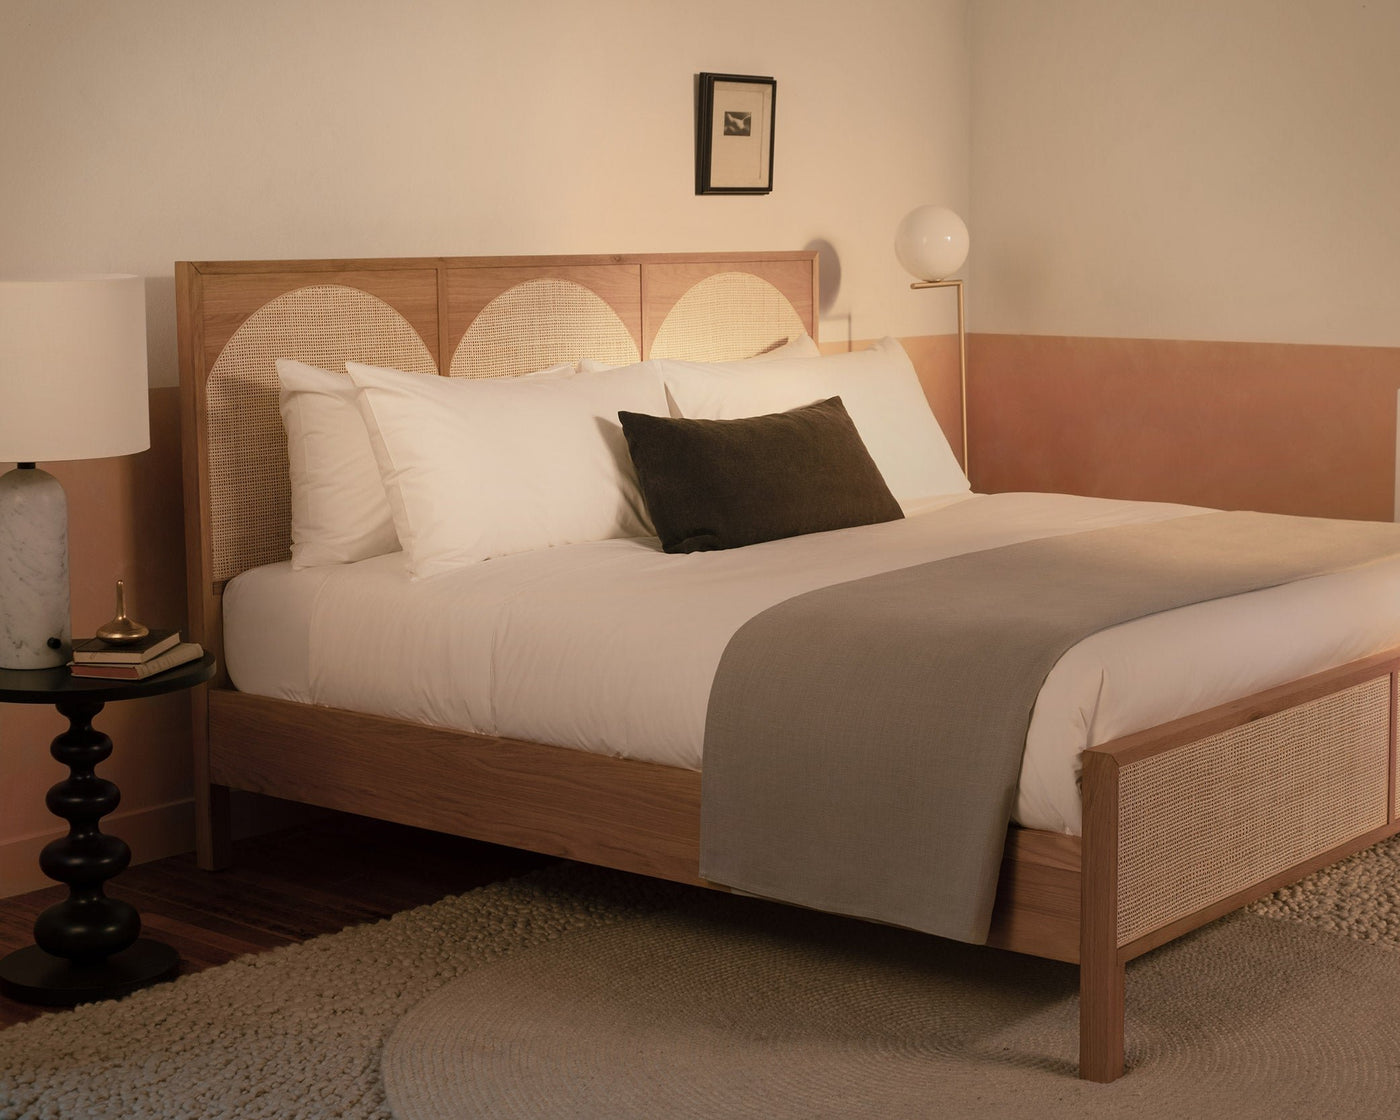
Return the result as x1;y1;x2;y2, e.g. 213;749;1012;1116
648;272;805;361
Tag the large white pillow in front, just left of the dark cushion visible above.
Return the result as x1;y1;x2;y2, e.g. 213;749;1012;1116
346;361;666;578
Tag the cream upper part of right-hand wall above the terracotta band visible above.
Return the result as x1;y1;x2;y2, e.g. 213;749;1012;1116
969;0;1400;346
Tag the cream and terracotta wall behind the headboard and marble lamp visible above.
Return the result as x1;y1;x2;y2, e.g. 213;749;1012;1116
0;0;970;895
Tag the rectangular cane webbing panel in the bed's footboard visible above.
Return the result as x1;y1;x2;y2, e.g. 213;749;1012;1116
1117;676;1390;945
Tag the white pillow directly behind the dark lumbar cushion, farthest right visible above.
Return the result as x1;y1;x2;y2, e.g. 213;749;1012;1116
645;339;972;505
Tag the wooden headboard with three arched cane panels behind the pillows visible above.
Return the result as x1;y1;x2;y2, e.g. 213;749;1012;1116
175;252;818;666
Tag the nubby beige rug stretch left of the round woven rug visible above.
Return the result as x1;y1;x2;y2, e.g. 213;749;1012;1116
0;864;680;1120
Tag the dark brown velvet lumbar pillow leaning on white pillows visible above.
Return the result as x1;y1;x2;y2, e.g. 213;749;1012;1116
617;396;904;552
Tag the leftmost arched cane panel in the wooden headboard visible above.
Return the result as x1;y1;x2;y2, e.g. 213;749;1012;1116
204;284;437;580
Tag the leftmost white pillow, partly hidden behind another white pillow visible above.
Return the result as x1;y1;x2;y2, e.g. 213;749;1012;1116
277;358;399;568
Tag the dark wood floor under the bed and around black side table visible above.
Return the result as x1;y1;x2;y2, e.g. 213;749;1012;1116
0;815;549;1028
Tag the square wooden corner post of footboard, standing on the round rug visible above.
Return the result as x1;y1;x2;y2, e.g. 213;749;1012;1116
1079;750;1124;1081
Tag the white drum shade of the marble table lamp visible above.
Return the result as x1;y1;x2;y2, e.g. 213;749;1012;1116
0;276;151;463
